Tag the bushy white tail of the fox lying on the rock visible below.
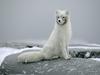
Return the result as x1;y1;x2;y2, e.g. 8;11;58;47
18;51;43;63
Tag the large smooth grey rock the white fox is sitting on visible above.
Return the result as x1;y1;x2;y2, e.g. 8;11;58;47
1;54;100;75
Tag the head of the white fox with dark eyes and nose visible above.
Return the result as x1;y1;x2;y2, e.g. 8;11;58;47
56;10;69;25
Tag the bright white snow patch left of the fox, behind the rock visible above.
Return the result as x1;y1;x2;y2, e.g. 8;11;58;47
0;47;41;65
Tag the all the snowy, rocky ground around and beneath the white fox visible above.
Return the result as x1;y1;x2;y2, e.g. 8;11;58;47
0;42;100;75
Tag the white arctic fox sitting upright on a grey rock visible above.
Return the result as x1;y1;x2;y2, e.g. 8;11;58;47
18;10;72;62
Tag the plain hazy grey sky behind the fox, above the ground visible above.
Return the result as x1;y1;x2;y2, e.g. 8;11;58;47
0;0;100;44
